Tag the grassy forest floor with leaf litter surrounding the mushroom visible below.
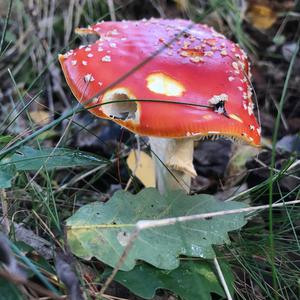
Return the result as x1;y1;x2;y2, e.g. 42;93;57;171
0;0;300;300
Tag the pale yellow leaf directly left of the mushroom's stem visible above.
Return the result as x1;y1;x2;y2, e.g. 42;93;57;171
127;150;155;187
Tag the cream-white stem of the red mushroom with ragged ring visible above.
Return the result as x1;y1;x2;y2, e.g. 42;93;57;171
150;137;197;194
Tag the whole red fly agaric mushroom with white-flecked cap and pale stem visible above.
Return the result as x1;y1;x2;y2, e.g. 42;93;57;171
59;19;261;192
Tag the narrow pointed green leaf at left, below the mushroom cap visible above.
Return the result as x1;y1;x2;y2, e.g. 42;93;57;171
0;146;109;171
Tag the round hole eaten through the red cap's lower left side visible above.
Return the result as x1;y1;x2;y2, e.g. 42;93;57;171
102;91;138;121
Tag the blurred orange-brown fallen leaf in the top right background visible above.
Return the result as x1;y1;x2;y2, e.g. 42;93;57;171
247;4;277;30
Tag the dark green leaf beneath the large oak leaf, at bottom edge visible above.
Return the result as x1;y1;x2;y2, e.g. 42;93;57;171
110;260;234;300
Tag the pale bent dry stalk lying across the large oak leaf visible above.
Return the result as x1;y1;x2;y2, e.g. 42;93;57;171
96;200;300;300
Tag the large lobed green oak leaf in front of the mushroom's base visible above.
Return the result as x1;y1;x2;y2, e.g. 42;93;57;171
67;188;246;271
